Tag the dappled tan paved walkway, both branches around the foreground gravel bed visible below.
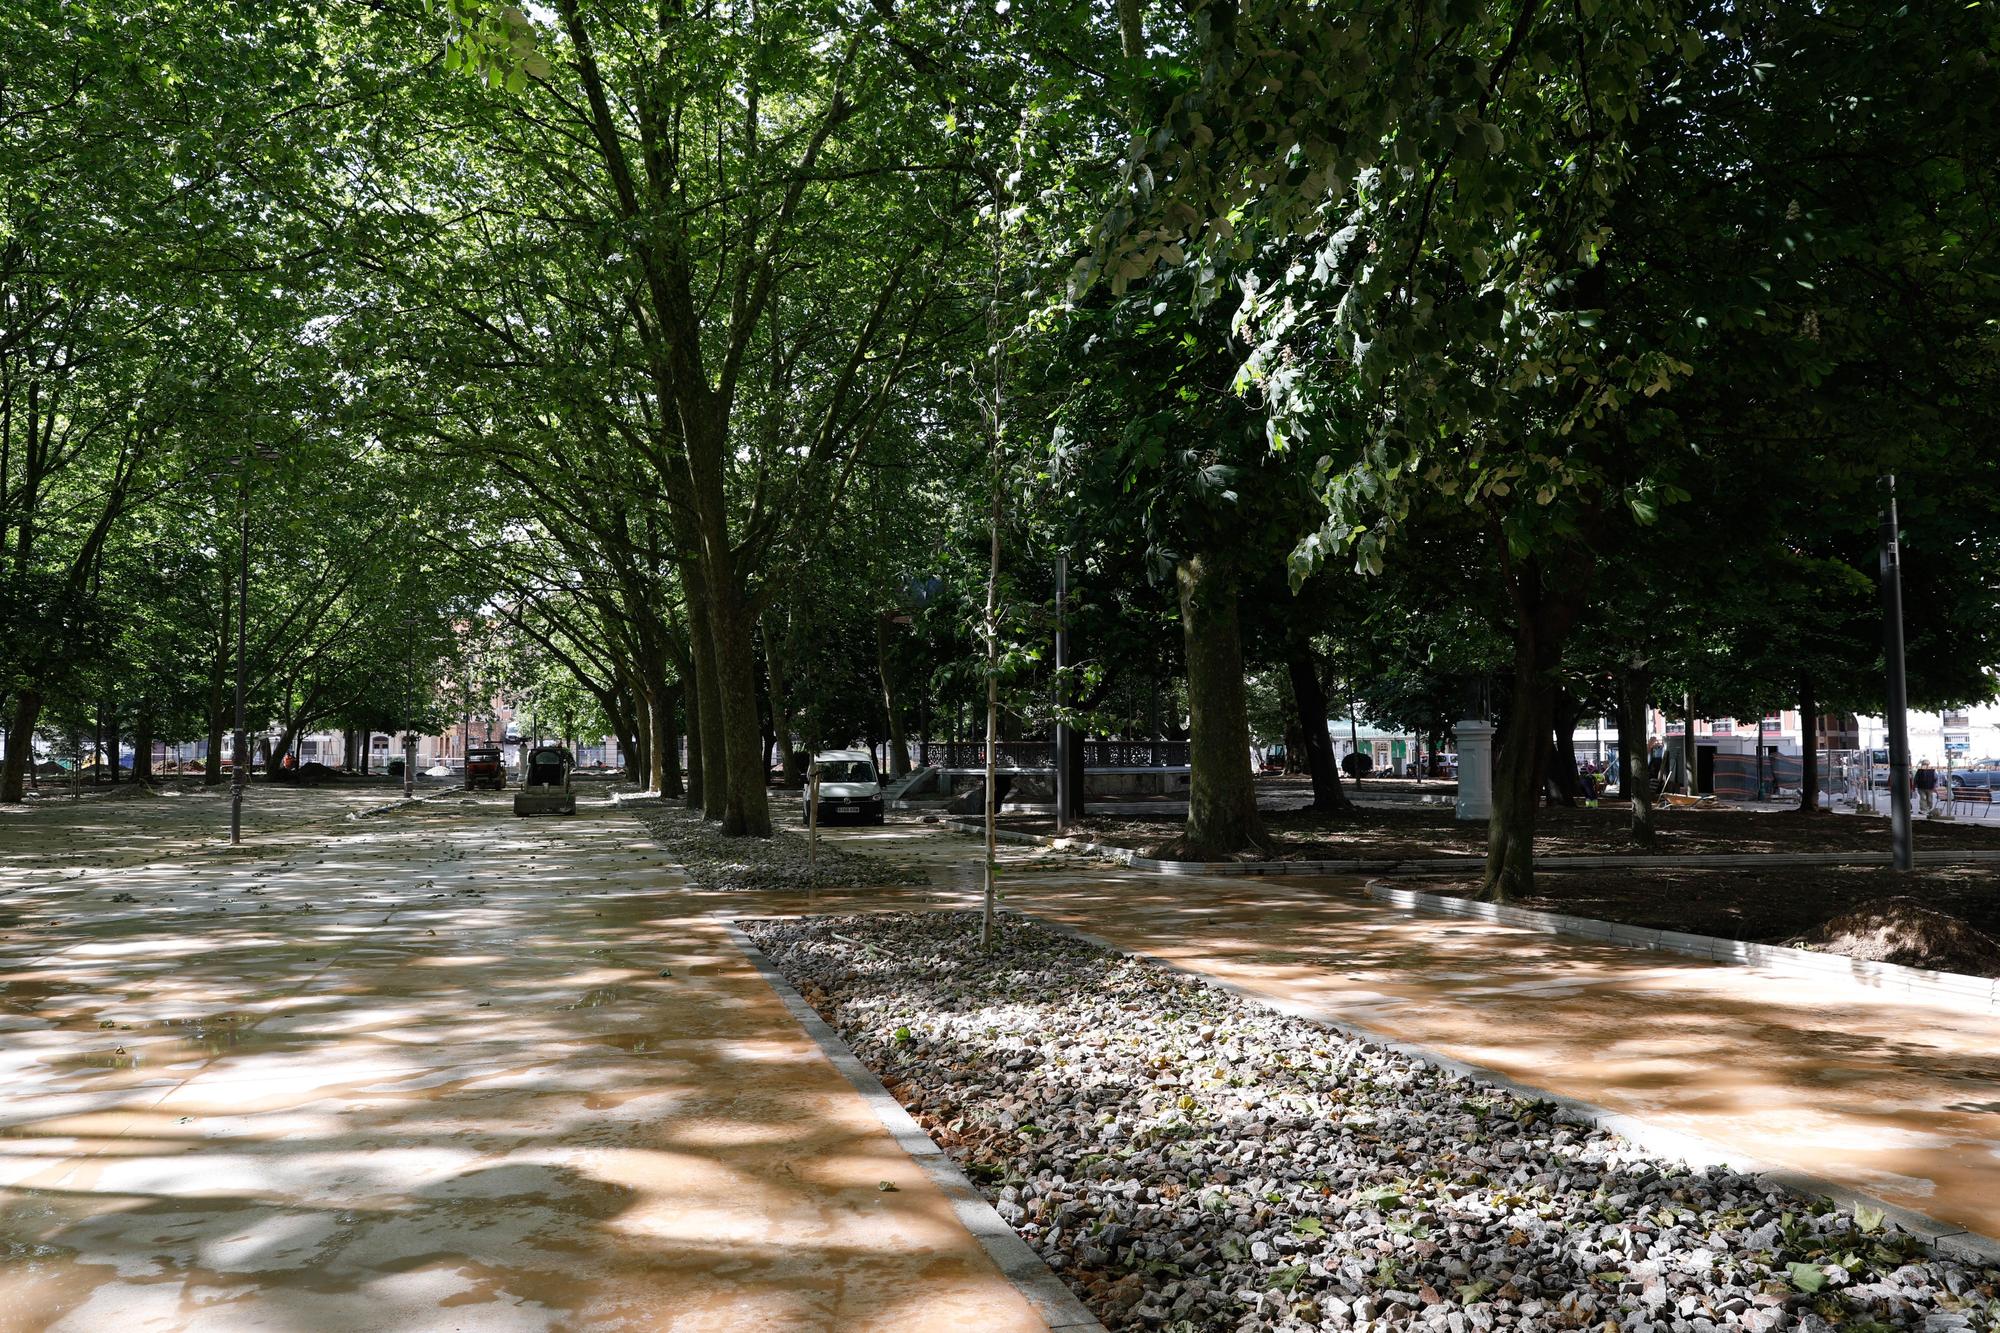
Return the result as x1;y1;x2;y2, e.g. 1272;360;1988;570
0;791;2000;1333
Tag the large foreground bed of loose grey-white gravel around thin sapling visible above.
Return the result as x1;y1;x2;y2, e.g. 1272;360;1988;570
744;913;2000;1333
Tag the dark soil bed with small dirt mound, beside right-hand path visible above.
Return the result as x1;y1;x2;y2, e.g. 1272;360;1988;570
1422;860;2000;977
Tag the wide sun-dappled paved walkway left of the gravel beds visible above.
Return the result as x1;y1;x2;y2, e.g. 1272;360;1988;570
0;791;1042;1333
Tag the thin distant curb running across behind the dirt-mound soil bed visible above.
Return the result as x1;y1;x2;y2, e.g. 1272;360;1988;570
938;817;2000;877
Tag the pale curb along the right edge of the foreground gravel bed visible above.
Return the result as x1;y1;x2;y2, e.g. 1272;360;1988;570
1032;909;2000;1267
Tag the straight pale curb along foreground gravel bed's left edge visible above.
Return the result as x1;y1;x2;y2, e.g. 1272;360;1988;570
716;913;1106;1333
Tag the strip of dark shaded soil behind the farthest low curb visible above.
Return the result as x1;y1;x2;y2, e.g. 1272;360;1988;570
1016;807;2000;861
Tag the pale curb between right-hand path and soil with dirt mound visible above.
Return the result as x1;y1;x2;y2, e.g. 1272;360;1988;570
1368;881;2000;1013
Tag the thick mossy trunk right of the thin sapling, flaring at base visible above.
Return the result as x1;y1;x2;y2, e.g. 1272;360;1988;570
1174;552;1270;859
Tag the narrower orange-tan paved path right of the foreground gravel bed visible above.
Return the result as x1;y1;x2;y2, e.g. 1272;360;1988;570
796;825;2000;1237
